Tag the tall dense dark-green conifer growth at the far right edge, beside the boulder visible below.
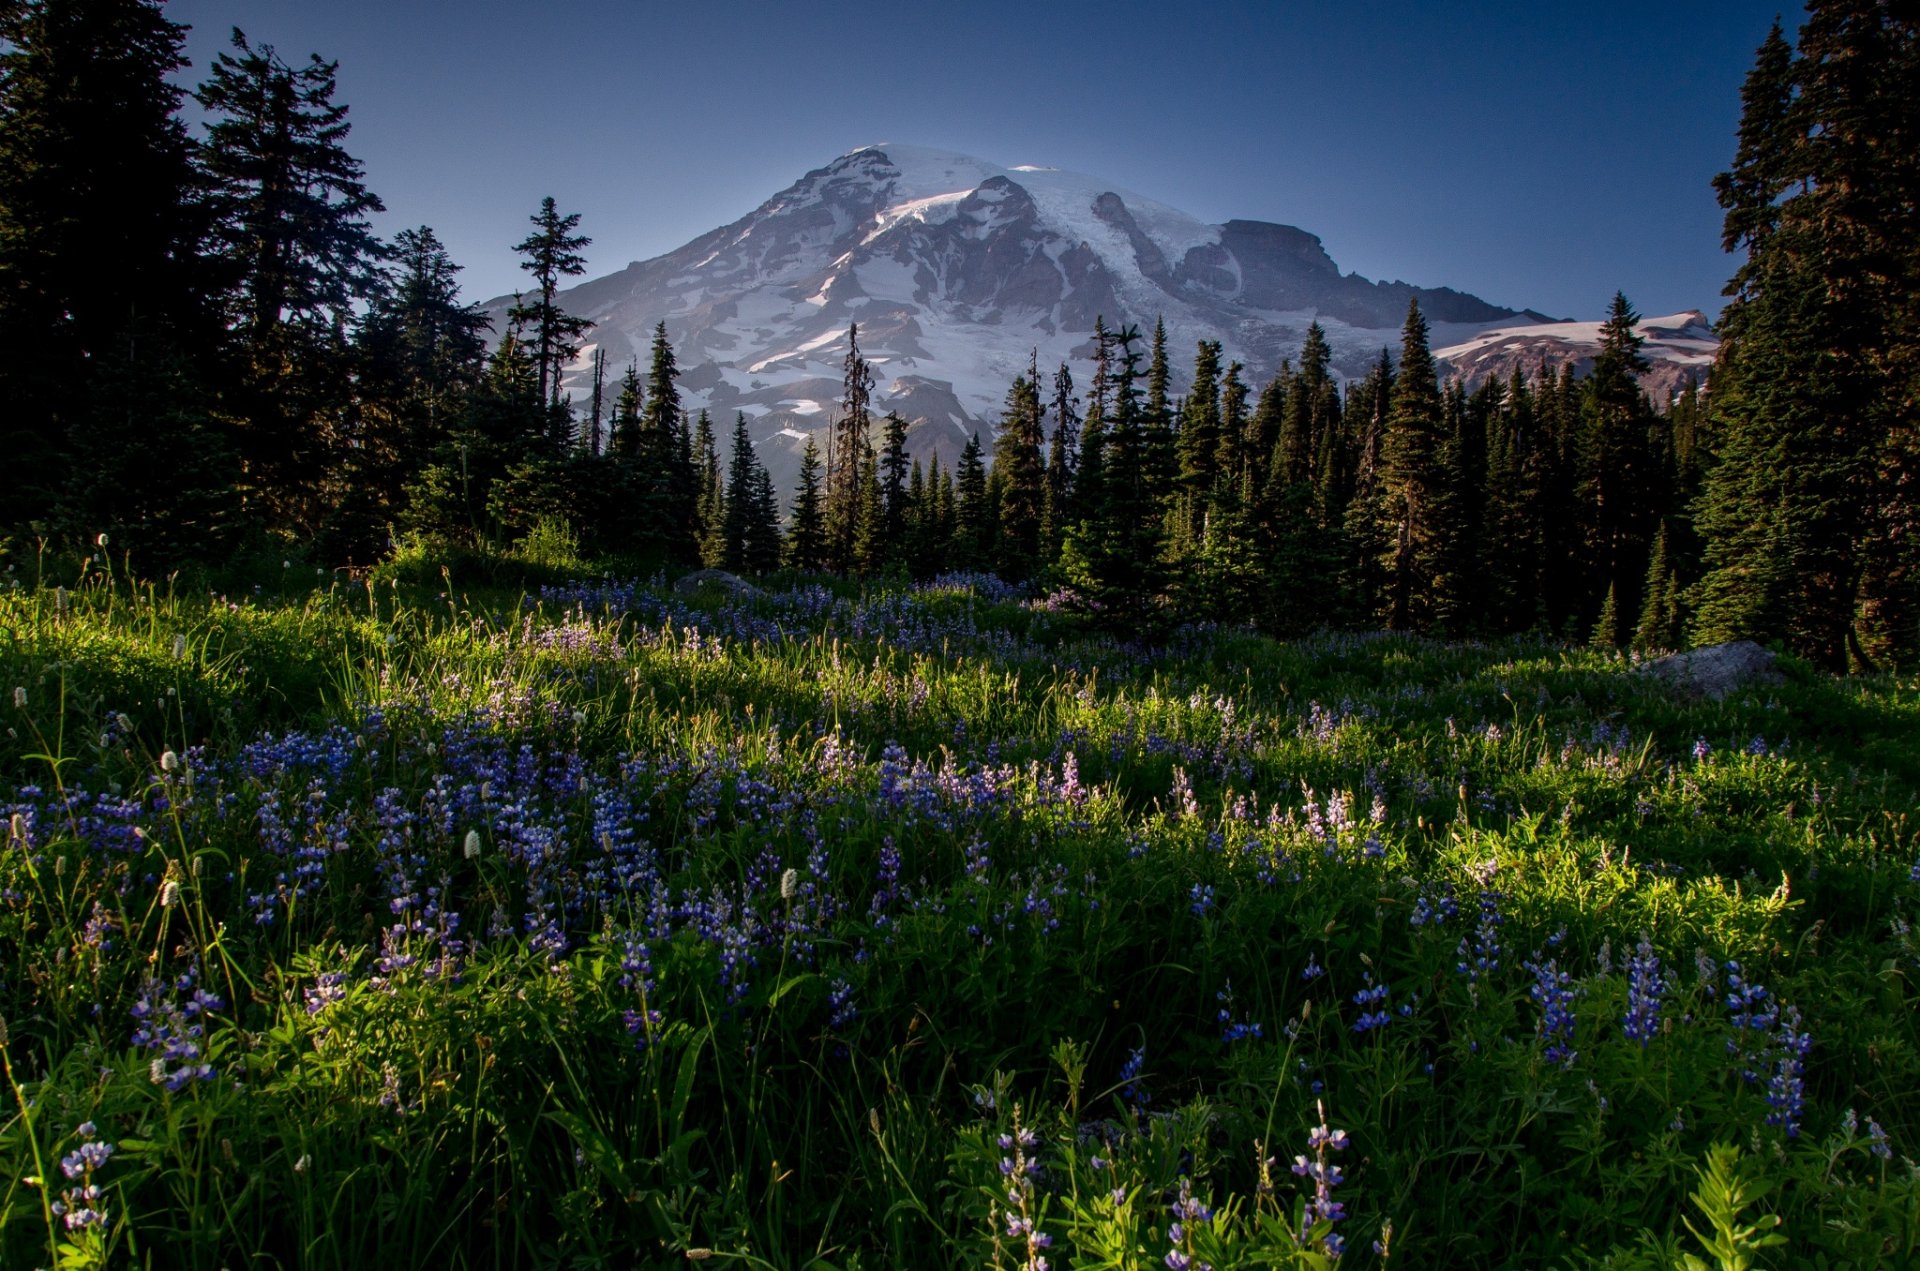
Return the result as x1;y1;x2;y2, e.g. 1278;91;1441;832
1692;9;1920;670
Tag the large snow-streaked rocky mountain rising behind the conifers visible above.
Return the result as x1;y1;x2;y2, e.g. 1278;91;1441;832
490;144;1712;488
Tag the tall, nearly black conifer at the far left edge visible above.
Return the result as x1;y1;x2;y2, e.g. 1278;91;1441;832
0;0;236;564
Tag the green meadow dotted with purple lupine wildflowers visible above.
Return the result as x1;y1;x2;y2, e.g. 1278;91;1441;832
0;561;1920;1271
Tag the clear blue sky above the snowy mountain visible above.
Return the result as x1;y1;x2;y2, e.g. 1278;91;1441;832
167;0;1774;319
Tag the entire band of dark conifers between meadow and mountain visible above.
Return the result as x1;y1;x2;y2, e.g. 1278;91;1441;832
0;0;1920;668
